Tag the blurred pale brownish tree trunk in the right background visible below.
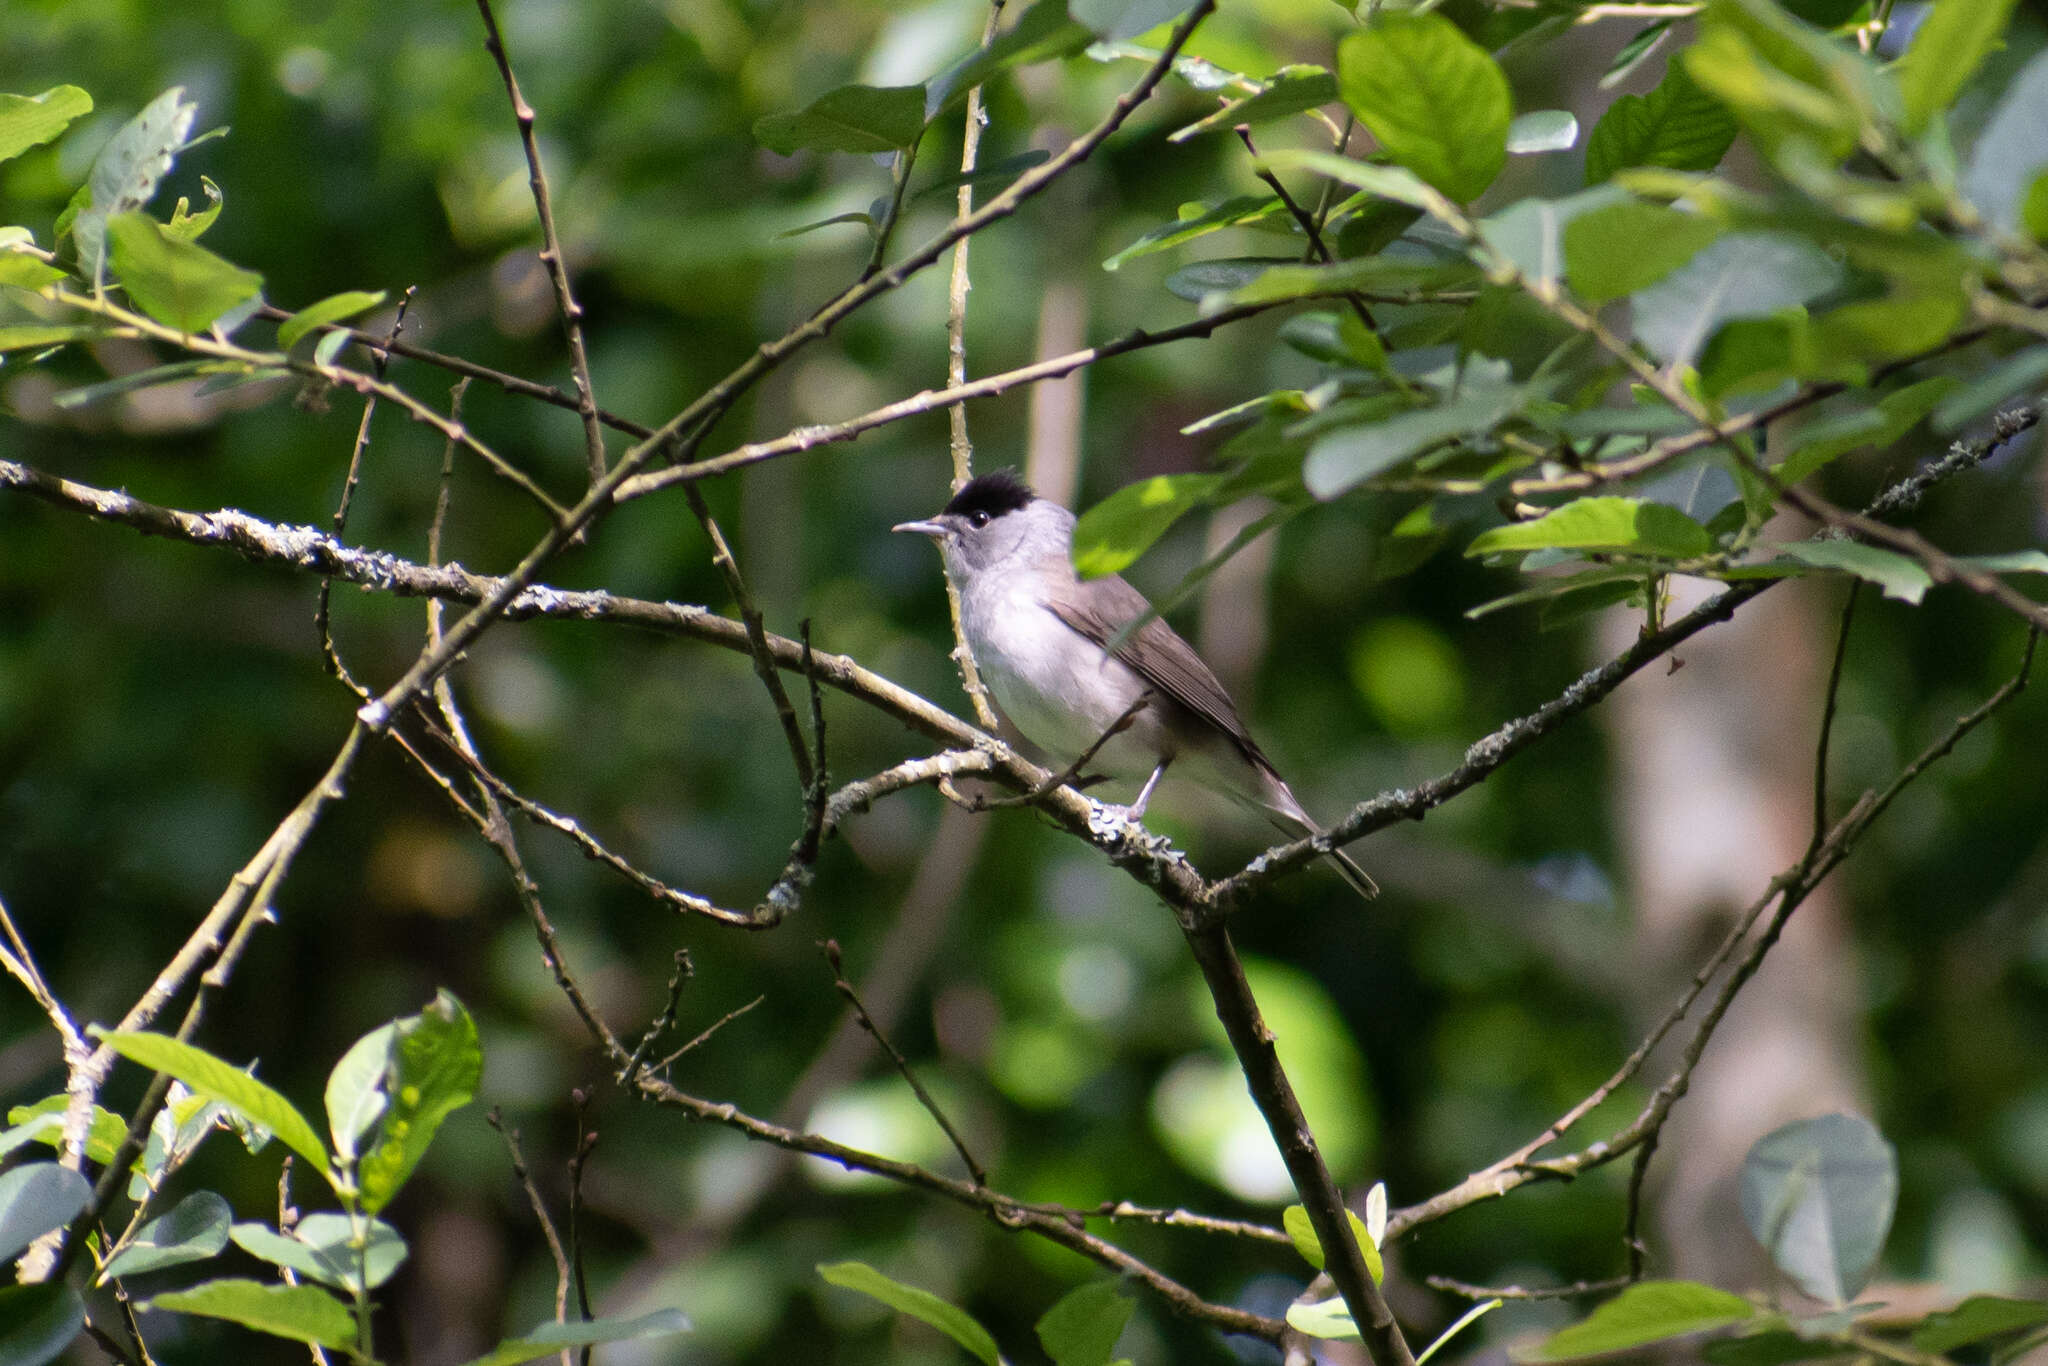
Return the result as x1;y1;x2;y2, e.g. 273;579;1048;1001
1599;580;1868;1288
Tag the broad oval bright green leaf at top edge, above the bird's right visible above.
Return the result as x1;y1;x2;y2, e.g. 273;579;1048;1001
1337;10;1513;203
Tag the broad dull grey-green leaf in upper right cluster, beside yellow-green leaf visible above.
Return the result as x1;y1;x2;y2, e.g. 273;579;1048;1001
1632;231;1841;365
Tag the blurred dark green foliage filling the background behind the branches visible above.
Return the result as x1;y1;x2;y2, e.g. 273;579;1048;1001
0;0;2048;1362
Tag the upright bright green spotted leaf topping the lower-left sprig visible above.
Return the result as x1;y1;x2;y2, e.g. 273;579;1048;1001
354;991;483;1214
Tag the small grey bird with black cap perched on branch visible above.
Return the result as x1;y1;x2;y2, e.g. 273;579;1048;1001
895;469;1380;897
